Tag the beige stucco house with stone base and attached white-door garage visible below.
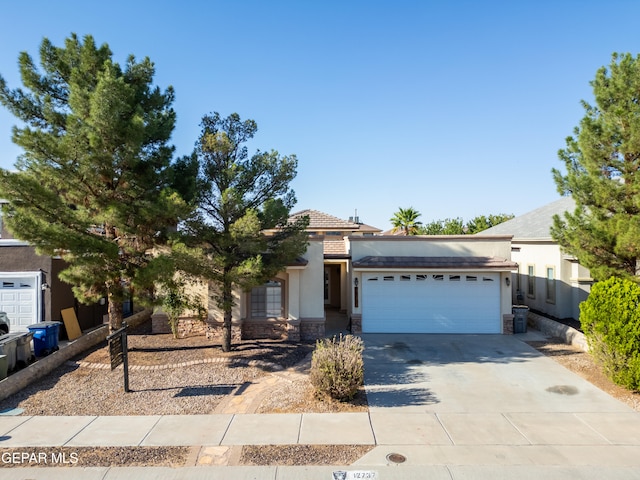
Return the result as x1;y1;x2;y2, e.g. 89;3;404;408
186;210;517;340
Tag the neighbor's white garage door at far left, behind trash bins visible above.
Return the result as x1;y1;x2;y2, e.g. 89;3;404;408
0;277;37;332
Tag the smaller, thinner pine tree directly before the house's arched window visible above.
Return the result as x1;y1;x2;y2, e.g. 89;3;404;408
183;113;308;352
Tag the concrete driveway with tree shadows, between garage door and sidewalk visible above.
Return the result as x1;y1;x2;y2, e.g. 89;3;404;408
362;333;633;413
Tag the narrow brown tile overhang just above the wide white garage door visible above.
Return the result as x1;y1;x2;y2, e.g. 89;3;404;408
353;256;518;271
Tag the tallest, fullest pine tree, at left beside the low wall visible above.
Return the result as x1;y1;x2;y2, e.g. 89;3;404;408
0;34;181;329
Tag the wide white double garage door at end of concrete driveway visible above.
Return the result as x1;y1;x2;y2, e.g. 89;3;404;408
362;272;501;333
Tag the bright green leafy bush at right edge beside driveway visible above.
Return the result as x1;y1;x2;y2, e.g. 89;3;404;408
580;277;640;390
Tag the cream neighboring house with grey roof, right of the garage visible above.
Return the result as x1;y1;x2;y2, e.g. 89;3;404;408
476;197;593;320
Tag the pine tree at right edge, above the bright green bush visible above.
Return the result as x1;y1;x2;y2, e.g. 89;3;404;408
551;54;640;281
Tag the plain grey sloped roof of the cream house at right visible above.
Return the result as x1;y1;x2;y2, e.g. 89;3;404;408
476;197;576;240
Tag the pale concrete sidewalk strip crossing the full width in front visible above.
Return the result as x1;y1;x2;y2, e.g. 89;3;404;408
0;410;640;450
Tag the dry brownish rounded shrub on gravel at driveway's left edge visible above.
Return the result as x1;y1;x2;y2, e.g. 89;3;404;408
310;335;364;402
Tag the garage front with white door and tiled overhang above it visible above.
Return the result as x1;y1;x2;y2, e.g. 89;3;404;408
353;255;517;334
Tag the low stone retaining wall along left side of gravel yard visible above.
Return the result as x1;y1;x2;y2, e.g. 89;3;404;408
0;310;151;400
